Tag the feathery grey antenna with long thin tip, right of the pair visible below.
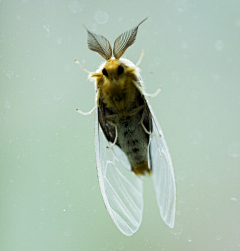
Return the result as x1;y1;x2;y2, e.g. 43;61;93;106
113;18;147;59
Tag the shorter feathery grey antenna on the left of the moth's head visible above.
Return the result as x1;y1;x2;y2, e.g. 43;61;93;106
85;27;112;60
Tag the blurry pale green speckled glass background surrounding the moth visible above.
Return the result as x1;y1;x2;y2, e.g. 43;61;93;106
0;0;240;251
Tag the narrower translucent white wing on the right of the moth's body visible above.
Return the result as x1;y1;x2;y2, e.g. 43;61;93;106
149;102;176;228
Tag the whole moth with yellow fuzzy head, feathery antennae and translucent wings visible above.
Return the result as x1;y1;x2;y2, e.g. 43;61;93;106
76;19;176;236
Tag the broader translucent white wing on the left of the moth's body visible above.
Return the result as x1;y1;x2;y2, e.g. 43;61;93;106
95;109;143;236
